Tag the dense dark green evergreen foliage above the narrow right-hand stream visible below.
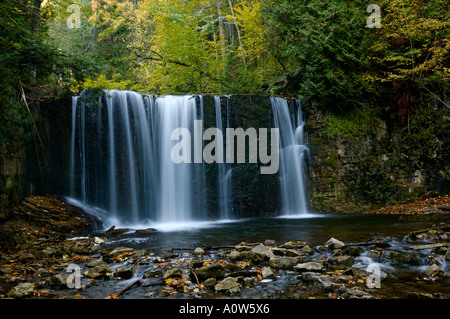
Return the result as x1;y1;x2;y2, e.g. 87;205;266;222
262;0;367;109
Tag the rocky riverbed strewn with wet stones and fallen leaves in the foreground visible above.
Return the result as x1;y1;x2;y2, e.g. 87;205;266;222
0;198;450;299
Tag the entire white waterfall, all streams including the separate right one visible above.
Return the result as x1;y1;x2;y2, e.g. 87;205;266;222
70;90;308;225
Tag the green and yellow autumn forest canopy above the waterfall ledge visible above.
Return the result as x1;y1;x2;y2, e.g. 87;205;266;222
0;0;450;113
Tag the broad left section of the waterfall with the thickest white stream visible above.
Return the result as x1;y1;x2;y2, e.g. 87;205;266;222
70;90;206;224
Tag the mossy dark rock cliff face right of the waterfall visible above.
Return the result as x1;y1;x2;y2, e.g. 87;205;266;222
306;101;450;213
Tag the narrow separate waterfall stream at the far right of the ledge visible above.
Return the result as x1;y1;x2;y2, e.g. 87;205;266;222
270;97;309;216
